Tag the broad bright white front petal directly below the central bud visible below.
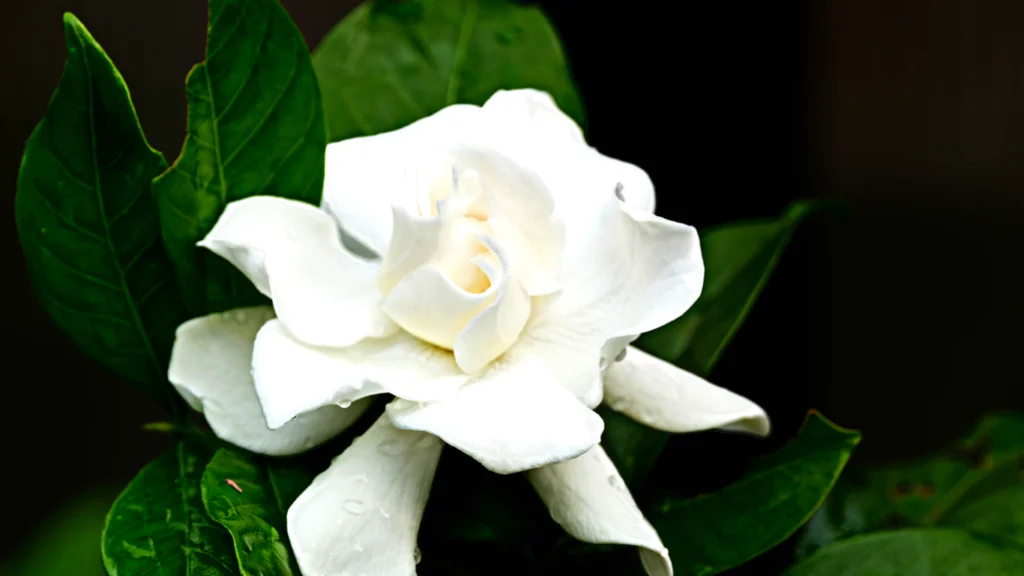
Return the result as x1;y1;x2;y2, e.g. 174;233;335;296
387;359;604;474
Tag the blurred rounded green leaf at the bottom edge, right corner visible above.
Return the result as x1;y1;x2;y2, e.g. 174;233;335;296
785;529;1024;576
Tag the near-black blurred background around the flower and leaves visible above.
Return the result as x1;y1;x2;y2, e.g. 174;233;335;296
0;0;1024;575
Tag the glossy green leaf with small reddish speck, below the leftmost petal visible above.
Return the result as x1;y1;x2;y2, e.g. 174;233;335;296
203;449;312;576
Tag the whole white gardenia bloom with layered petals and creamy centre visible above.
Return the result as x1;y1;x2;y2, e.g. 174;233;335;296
170;90;768;576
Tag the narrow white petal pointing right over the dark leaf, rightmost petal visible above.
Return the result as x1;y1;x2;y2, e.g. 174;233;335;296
604;346;771;436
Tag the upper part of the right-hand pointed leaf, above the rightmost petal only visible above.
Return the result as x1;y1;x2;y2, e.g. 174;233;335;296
637;202;814;376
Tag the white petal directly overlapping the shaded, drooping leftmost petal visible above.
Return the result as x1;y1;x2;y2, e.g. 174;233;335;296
252;320;467;428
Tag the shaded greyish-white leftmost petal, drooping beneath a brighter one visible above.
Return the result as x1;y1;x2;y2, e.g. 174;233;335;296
167;307;362;456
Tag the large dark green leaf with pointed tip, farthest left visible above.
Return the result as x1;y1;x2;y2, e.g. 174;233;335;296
14;13;184;410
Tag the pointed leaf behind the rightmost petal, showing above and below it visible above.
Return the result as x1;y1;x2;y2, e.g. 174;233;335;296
598;202;816;488
